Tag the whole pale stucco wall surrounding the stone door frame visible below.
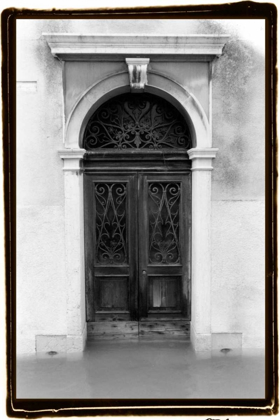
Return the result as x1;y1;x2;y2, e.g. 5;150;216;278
17;20;264;352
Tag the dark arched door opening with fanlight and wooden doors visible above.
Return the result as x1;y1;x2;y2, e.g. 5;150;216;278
82;93;192;337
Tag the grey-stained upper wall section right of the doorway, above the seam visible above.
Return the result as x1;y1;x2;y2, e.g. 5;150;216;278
199;21;265;199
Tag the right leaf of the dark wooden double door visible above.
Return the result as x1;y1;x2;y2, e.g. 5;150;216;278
139;174;190;319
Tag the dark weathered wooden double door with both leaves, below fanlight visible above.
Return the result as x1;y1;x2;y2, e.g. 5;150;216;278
84;171;191;333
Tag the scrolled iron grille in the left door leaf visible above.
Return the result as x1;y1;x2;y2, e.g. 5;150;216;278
95;182;127;265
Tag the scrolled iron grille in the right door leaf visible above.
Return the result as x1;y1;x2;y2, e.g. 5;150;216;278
148;182;181;264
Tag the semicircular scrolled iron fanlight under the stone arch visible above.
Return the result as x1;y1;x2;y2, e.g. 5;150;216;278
84;93;191;150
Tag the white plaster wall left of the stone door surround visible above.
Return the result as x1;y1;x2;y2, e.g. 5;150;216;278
16;23;66;353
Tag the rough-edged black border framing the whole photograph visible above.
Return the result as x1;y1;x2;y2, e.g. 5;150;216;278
1;1;279;418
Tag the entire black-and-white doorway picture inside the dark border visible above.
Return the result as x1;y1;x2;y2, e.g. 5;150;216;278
2;1;278;411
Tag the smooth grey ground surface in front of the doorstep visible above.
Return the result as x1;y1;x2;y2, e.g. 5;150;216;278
17;339;265;399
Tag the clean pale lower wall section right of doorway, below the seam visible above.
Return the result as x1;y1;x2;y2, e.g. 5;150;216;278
211;200;265;347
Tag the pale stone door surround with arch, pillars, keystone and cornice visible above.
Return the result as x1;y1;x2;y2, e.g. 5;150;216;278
50;34;225;352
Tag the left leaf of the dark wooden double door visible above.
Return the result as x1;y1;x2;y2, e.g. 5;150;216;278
85;174;138;321
